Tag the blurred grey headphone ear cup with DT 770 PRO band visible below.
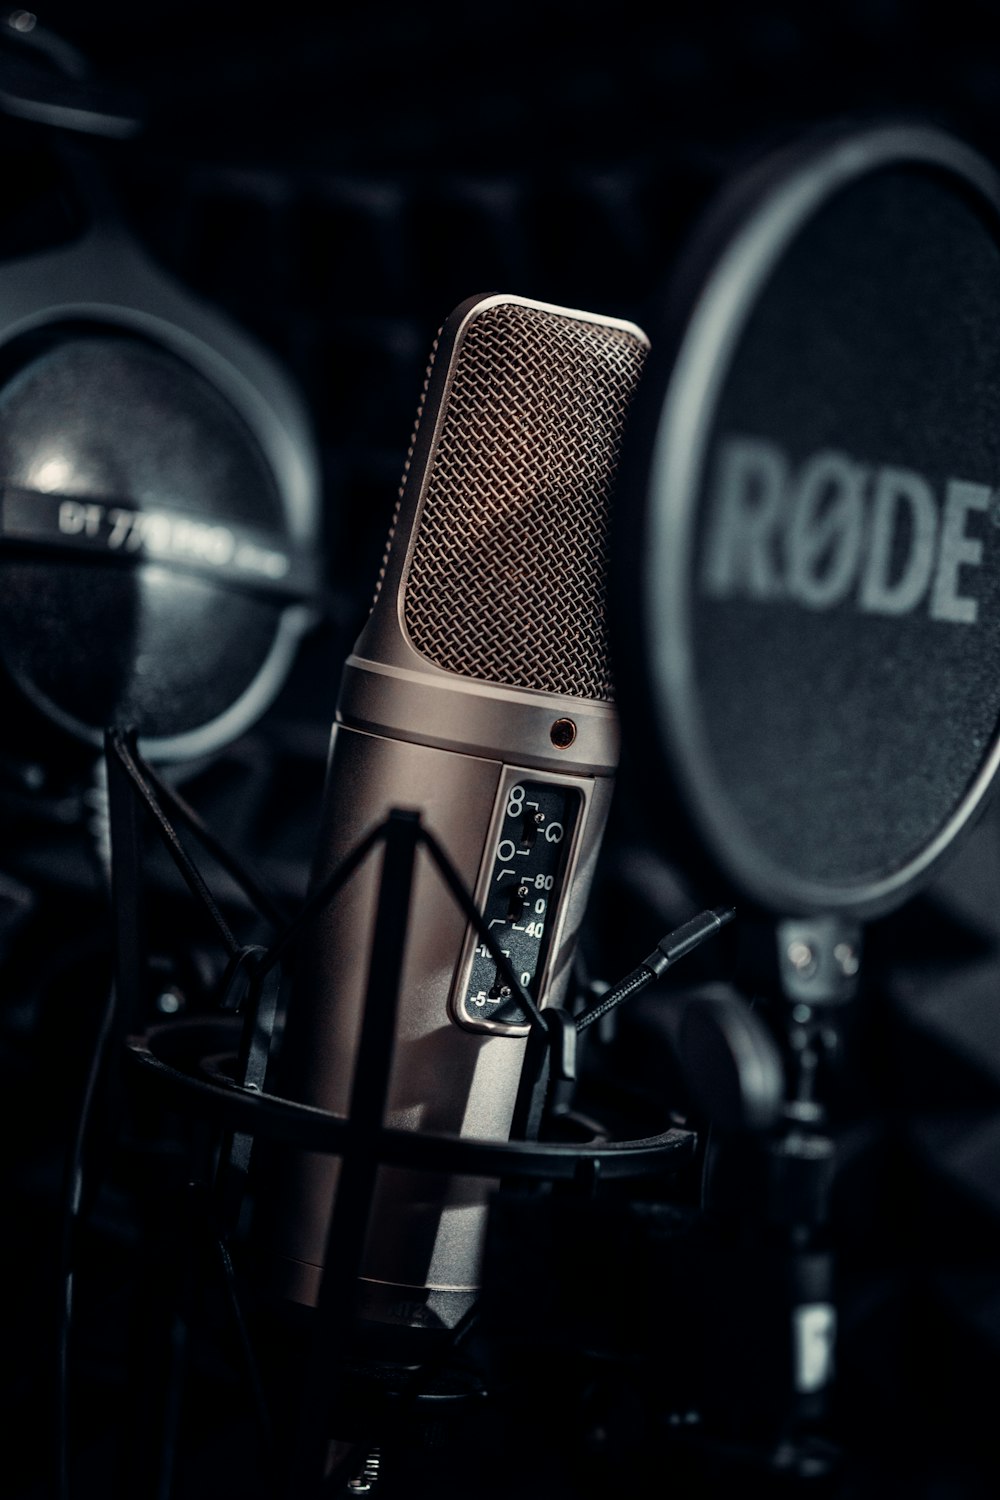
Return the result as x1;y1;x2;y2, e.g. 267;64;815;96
0;135;322;780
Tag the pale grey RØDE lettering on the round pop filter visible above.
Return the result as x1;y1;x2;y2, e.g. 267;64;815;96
700;437;994;626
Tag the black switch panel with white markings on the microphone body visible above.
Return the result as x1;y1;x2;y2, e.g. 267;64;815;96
456;779;583;1035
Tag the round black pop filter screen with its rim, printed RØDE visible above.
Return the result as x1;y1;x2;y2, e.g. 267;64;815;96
613;128;1000;914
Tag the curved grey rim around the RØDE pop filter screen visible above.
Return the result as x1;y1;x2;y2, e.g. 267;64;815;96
615;120;1000;918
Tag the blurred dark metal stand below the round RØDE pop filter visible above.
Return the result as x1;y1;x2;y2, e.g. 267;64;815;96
695;915;862;1494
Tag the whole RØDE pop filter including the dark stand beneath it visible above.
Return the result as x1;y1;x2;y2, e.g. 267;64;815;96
612;120;1000;1485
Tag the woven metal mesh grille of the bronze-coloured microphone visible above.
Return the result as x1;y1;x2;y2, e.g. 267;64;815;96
392;303;646;701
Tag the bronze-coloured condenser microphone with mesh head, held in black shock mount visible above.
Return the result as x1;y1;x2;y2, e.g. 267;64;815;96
264;296;648;1328
